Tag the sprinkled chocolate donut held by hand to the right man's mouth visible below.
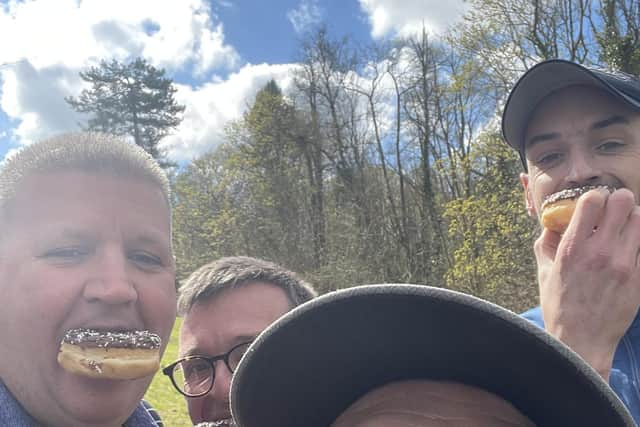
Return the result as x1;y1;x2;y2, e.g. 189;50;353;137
541;185;615;233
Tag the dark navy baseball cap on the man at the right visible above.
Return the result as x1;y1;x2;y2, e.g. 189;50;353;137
502;59;640;162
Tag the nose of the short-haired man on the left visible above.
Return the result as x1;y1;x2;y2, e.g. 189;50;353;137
84;248;138;304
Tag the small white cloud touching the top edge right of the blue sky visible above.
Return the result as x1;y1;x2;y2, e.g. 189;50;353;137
359;0;468;38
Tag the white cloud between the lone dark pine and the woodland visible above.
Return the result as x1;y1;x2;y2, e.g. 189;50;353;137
162;64;296;162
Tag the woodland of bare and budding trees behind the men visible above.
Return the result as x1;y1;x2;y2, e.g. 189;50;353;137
174;0;640;310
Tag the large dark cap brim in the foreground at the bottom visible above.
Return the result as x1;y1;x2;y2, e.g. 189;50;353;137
231;285;635;427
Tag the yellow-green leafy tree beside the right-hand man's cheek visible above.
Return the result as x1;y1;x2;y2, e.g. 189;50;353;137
444;133;537;310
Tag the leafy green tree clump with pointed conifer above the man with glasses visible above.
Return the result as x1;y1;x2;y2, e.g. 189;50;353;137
174;81;314;277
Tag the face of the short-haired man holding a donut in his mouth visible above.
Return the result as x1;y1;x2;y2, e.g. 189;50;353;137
0;172;176;426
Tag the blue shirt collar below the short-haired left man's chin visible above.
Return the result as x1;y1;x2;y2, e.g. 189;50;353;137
0;381;158;427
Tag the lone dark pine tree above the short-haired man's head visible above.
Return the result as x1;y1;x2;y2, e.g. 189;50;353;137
65;58;185;166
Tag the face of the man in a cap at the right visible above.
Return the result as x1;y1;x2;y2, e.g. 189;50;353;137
521;86;640;221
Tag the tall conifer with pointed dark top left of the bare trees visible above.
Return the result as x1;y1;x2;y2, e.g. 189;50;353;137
227;81;311;265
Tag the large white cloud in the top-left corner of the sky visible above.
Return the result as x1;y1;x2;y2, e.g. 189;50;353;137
0;0;238;70
